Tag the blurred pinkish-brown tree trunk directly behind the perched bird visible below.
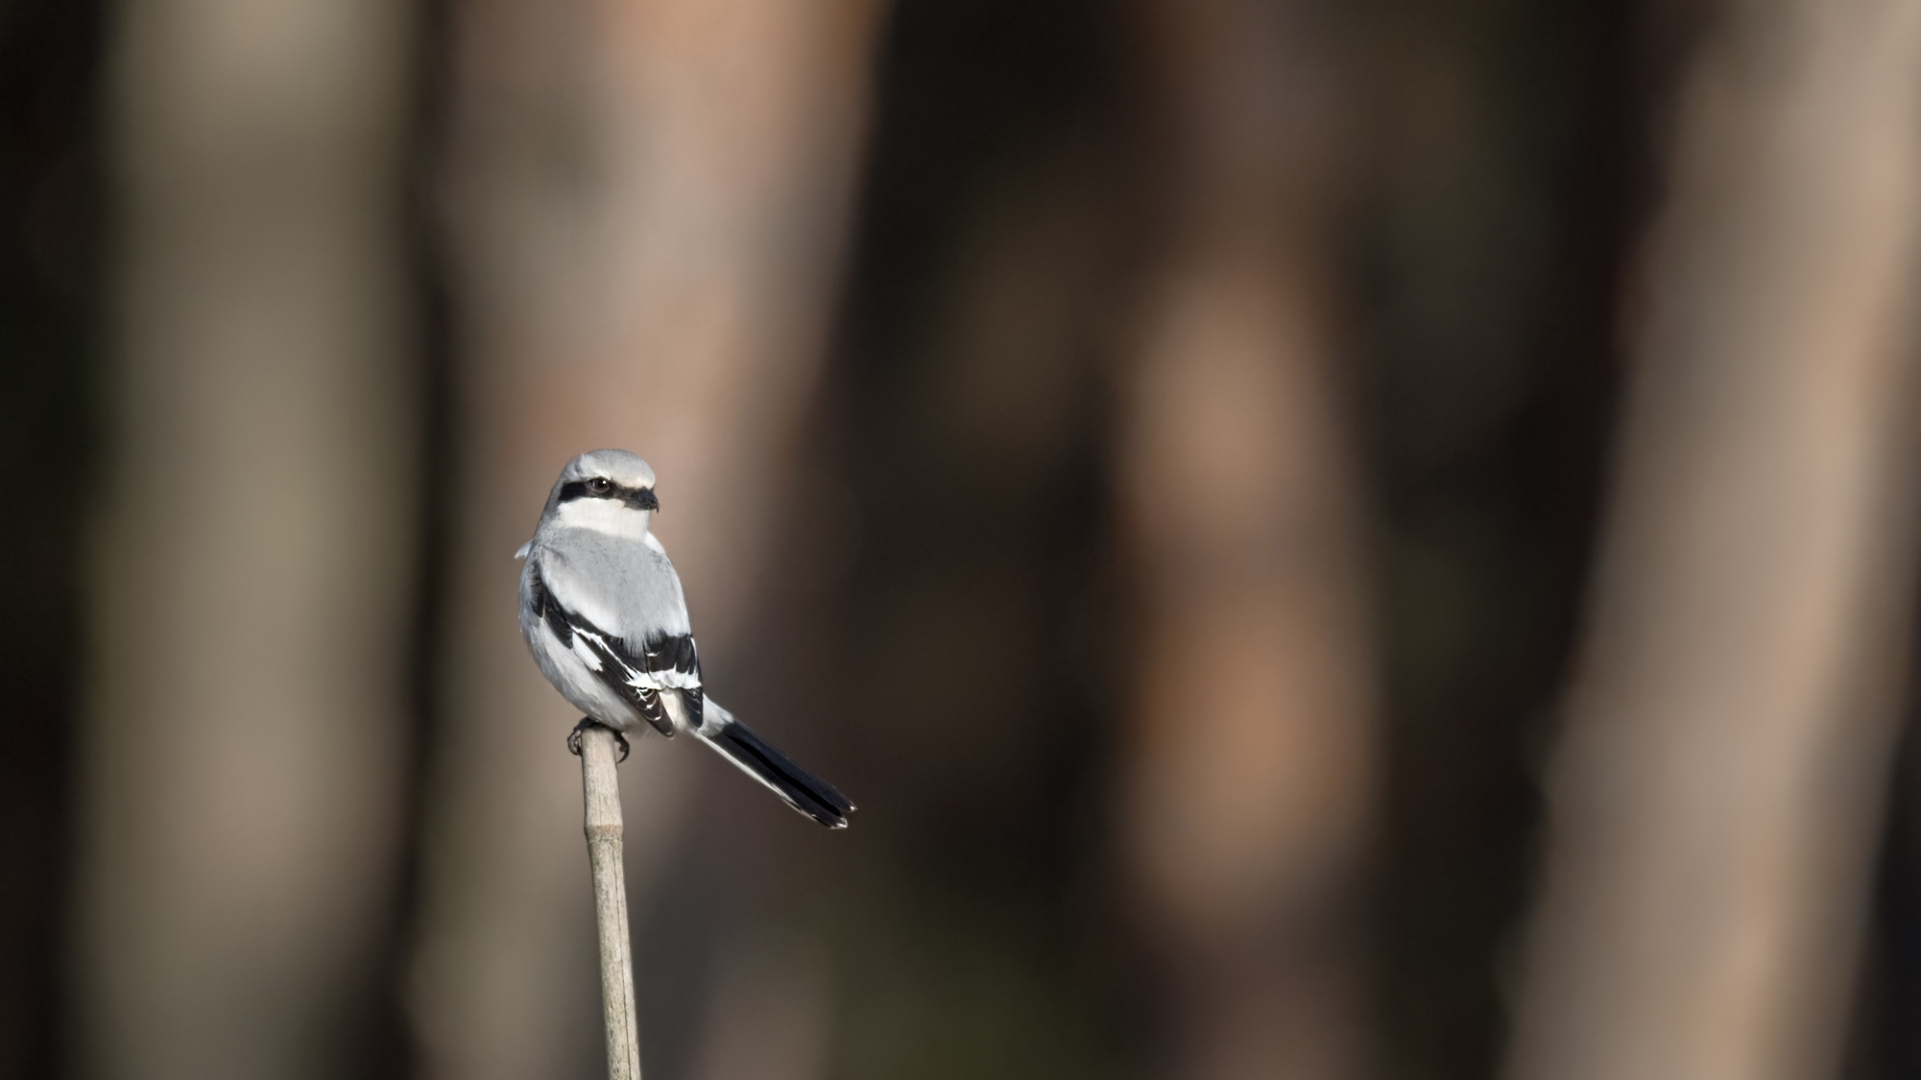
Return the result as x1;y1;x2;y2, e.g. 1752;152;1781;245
411;0;876;1078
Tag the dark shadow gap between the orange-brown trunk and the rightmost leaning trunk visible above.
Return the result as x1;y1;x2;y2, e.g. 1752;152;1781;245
1356;4;1654;1080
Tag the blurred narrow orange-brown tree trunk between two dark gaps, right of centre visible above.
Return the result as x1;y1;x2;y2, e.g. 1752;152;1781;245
1118;0;1374;1080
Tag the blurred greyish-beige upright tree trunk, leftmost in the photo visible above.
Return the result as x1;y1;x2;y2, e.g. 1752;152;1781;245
71;0;417;1080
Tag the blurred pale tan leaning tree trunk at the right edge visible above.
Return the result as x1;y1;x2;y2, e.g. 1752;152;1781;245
1510;0;1921;1080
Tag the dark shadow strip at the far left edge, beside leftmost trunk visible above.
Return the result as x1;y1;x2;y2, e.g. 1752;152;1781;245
0;0;104;1080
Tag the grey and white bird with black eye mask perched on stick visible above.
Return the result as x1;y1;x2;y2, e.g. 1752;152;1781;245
515;450;855;828
